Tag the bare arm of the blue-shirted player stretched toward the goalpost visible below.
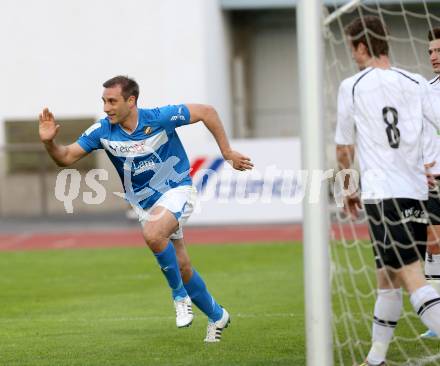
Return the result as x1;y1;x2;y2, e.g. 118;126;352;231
186;104;254;170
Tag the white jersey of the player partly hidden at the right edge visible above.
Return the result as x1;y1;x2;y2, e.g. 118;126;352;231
424;76;440;175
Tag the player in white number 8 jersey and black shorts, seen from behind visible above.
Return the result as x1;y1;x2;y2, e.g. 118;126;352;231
335;16;440;365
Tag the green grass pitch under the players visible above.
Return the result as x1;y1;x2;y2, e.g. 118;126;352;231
0;243;440;366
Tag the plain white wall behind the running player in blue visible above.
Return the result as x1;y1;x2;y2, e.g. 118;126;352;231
0;0;231;148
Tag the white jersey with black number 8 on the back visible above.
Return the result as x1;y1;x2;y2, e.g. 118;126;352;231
335;67;440;200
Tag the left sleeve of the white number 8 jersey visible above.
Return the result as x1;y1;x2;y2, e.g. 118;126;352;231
335;82;355;145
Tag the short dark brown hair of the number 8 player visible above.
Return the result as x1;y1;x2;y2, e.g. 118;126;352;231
345;15;389;57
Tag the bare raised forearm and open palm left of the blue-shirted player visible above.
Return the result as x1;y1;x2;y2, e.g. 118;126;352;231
39;108;87;167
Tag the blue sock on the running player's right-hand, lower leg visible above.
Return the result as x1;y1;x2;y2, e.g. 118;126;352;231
184;268;223;322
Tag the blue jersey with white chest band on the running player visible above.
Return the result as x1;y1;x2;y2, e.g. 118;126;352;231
77;105;192;209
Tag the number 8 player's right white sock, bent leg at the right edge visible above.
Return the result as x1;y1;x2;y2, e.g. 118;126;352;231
410;285;440;334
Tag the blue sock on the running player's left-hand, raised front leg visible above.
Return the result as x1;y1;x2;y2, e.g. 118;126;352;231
154;242;188;300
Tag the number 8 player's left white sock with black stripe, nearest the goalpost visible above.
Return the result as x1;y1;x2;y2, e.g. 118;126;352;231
367;289;402;365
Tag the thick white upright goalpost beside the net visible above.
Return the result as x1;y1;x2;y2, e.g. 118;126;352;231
296;0;333;366
